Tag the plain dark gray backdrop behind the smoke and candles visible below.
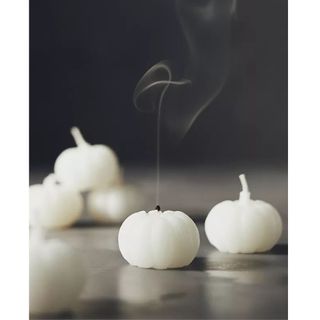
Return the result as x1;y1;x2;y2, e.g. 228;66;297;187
30;0;287;168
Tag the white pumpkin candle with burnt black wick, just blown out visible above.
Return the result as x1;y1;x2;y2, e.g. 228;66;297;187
118;206;200;269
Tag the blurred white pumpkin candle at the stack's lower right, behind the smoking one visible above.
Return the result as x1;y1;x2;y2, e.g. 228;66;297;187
87;185;143;223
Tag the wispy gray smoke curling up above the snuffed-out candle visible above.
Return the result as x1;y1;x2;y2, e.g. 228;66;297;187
133;0;236;142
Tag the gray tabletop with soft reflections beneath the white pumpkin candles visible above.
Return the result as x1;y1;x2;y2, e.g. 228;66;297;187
30;169;288;319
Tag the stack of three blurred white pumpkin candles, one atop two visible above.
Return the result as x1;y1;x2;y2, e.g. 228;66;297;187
30;127;143;228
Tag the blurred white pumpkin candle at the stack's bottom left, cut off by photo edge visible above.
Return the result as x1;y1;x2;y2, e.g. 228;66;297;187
29;174;83;228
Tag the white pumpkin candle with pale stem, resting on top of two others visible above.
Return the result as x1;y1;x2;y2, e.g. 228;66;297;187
54;127;120;191
